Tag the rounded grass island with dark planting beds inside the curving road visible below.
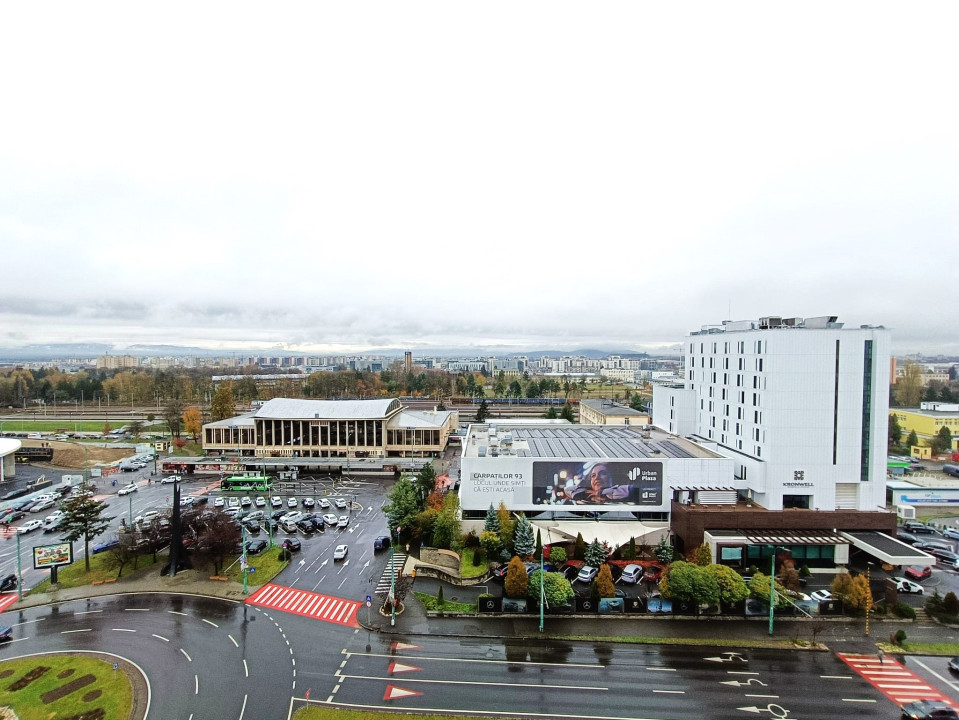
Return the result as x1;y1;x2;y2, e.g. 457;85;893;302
0;655;133;720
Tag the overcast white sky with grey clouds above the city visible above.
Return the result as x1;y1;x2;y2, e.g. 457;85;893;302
0;0;959;353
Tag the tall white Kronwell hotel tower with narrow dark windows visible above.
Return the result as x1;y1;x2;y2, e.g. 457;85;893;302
653;316;890;510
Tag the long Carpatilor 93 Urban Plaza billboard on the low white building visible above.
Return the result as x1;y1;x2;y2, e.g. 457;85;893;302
460;458;670;512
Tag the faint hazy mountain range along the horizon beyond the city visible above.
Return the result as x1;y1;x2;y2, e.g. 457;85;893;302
0;343;679;362
